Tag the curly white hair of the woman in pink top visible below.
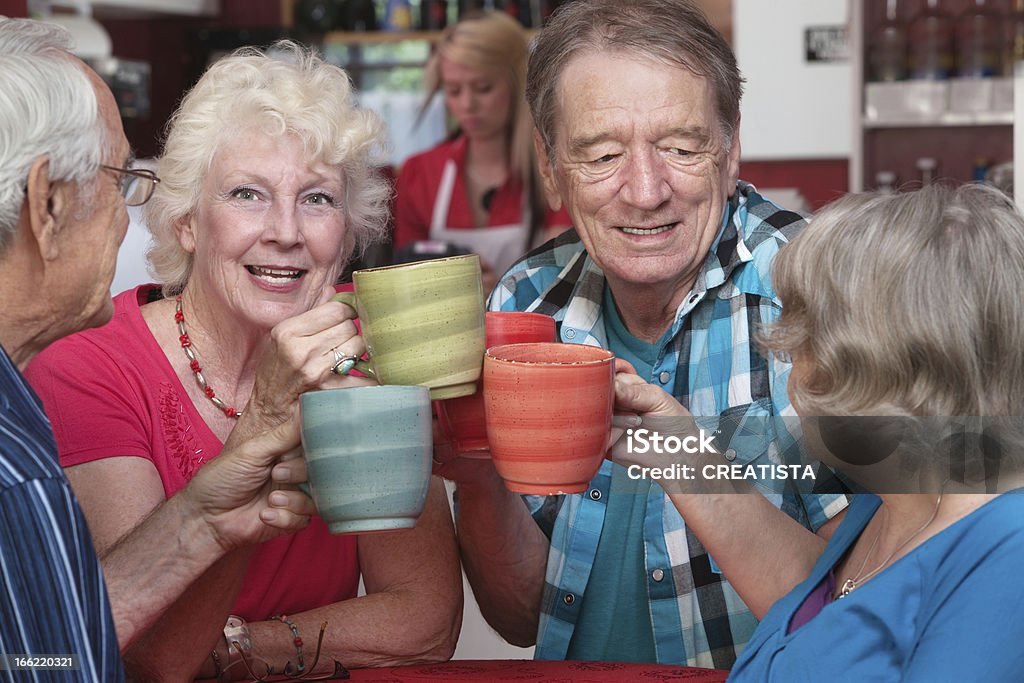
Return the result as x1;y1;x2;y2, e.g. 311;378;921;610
143;41;391;295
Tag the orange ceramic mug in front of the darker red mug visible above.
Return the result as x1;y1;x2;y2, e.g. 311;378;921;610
483;343;614;495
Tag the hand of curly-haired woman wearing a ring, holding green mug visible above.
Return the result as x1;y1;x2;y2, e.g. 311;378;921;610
237;288;377;445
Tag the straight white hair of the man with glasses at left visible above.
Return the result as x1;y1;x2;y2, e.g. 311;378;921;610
0;17;108;250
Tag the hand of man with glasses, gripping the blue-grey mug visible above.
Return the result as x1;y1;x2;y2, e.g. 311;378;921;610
181;418;316;551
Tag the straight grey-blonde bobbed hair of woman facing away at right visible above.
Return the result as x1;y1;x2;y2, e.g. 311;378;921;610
761;184;1024;416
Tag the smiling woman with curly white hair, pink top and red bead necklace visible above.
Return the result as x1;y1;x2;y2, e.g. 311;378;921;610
29;42;462;680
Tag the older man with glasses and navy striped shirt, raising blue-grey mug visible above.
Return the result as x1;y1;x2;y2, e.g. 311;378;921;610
0;17;313;681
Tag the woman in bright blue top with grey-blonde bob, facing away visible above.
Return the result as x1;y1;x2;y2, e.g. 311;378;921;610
620;184;1024;682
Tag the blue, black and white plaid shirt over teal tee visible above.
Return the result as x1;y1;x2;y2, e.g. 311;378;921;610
490;182;847;669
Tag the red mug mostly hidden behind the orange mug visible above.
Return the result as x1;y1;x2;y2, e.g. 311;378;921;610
434;311;555;458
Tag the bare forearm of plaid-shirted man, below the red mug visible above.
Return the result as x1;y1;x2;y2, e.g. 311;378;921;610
456;476;549;647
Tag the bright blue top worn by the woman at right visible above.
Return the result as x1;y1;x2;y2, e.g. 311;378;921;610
729;489;1024;683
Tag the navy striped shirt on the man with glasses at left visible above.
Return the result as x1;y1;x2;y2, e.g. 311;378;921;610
0;348;125;683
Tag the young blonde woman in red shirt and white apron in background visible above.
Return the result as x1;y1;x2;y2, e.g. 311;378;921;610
394;11;570;289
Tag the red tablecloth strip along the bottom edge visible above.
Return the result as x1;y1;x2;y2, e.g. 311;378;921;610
350;659;729;683
